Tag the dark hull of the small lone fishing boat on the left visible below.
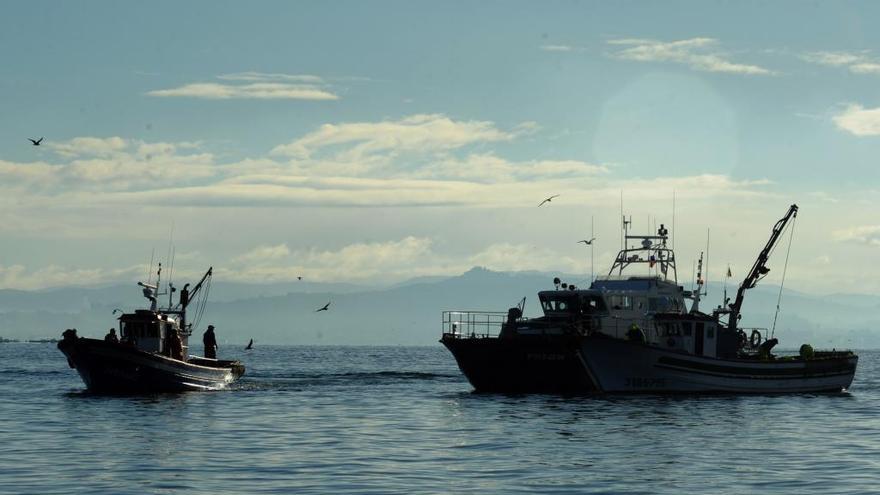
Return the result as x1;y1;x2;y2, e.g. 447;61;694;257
58;338;244;394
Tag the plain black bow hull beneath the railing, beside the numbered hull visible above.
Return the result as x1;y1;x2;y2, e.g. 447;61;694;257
441;336;597;393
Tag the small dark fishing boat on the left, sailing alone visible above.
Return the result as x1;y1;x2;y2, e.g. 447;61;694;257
58;264;245;394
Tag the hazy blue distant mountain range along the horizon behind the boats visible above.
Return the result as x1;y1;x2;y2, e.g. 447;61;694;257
0;268;880;349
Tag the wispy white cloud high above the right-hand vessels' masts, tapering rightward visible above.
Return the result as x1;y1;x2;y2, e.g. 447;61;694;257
608;38;774;75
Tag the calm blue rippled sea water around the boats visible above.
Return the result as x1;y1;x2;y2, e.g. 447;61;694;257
0;344;880;495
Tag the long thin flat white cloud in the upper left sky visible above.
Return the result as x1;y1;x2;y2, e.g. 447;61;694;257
147;82;339;100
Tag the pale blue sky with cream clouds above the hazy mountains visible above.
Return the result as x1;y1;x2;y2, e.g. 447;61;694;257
0;1;880;294
